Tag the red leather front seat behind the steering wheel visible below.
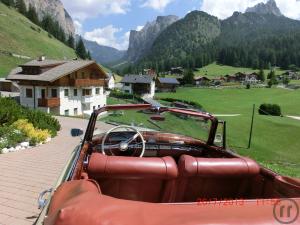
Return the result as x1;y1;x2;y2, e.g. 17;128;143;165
88;153;178;203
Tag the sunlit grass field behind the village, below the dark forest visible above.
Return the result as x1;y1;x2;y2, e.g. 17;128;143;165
195;63;284;77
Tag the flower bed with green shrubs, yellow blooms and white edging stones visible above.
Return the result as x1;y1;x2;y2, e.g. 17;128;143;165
0;98;60;153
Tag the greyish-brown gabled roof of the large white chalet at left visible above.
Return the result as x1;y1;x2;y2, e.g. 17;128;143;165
7;60;106;82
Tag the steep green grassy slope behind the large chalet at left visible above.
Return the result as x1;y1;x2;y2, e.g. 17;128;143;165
0;3;76;77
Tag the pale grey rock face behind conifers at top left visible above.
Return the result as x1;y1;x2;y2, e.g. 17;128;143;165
24;0;75;35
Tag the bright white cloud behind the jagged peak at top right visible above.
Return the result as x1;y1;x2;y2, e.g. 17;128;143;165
201;0;300;19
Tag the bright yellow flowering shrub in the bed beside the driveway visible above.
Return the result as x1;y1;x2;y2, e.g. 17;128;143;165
12;119;50;145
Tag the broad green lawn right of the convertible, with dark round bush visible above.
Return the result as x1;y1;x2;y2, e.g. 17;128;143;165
158;88;300;177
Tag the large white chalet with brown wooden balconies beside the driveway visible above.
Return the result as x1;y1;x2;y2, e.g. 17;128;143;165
7;58;108;116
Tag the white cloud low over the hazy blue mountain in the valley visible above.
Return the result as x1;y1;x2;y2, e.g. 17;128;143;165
84;25;130;50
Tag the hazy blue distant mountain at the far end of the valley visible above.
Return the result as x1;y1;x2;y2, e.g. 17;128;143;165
83;39;126;65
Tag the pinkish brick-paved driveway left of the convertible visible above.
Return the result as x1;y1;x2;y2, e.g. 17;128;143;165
0;117;111;225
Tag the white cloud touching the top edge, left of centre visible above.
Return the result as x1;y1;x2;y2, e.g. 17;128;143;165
62;0;131;21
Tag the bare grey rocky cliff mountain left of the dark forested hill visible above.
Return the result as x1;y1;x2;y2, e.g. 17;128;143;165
126;15;178;62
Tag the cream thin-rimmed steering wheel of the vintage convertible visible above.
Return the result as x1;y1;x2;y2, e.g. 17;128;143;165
101;125;146;157
